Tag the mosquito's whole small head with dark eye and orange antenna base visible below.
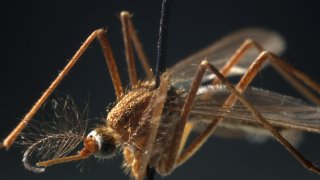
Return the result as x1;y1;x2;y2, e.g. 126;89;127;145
84;130;116;159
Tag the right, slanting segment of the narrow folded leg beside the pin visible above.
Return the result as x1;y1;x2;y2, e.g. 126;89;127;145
128;11;153;79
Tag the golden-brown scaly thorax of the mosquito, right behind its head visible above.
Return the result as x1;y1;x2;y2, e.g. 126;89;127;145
96;81;179;179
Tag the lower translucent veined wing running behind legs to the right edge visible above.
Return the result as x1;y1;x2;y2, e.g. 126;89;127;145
169;85;320;133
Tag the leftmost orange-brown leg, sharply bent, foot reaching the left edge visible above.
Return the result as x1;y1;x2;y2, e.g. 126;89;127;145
0;29;123;149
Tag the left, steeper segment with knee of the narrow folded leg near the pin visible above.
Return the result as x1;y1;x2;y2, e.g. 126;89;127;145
120;11;138;86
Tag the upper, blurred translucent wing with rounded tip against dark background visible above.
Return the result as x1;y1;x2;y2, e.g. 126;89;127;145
168;28;285;84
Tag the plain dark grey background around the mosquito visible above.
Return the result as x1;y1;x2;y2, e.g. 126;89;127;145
0;0;320;180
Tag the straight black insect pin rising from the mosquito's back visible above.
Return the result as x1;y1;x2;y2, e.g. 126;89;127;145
155;0;171;88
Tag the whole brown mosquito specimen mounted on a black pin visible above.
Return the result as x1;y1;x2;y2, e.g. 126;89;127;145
1;0;320;180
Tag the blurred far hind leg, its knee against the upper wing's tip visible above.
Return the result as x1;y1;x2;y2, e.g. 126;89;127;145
213;39;320;105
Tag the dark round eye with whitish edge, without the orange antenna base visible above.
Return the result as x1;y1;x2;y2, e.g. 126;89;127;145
87;130;116;159
